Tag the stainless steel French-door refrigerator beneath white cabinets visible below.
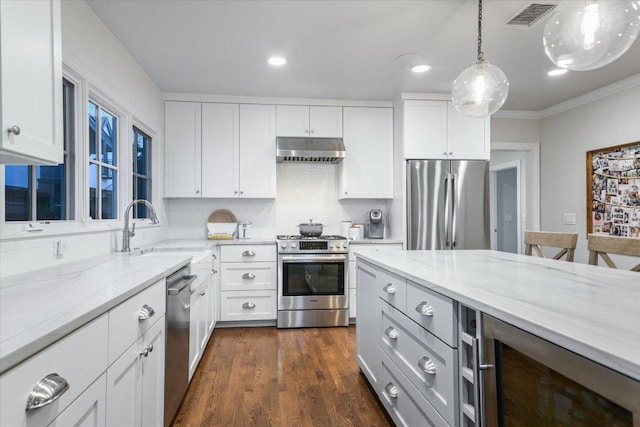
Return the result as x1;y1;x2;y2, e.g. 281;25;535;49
407;160;490;250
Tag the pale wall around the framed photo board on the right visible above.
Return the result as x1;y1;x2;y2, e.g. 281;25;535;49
540;86;640;268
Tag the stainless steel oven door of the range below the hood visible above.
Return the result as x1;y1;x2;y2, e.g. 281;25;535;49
278;254;349;310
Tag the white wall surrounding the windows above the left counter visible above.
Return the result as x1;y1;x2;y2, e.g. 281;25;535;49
0;1;165;277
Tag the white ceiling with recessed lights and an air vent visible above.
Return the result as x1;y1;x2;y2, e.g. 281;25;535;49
87;0;640;111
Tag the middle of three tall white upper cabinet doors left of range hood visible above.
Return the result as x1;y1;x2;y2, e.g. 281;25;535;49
202;103;240;197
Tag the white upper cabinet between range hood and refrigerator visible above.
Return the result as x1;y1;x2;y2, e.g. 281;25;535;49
338;107;393;199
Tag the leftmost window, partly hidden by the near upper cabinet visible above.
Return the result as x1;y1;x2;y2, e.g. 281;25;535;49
4;79;75;221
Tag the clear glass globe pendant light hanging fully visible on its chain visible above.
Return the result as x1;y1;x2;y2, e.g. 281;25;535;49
451;0;509;117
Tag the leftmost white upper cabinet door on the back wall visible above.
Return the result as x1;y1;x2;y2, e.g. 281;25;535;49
164;101;202;197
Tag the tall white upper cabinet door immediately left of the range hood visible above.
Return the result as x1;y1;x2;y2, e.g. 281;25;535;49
238;104;276;198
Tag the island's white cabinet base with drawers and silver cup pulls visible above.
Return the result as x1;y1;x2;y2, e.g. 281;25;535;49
356;260;460;426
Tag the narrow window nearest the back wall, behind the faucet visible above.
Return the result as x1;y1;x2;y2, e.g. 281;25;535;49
131;126;151;218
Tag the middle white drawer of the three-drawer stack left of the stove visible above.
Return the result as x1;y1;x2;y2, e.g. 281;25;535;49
221;262;277;291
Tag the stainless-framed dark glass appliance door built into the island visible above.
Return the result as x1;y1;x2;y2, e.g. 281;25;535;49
476;315;640;427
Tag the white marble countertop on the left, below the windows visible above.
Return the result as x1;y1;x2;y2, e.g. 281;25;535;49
0;252;191;374
